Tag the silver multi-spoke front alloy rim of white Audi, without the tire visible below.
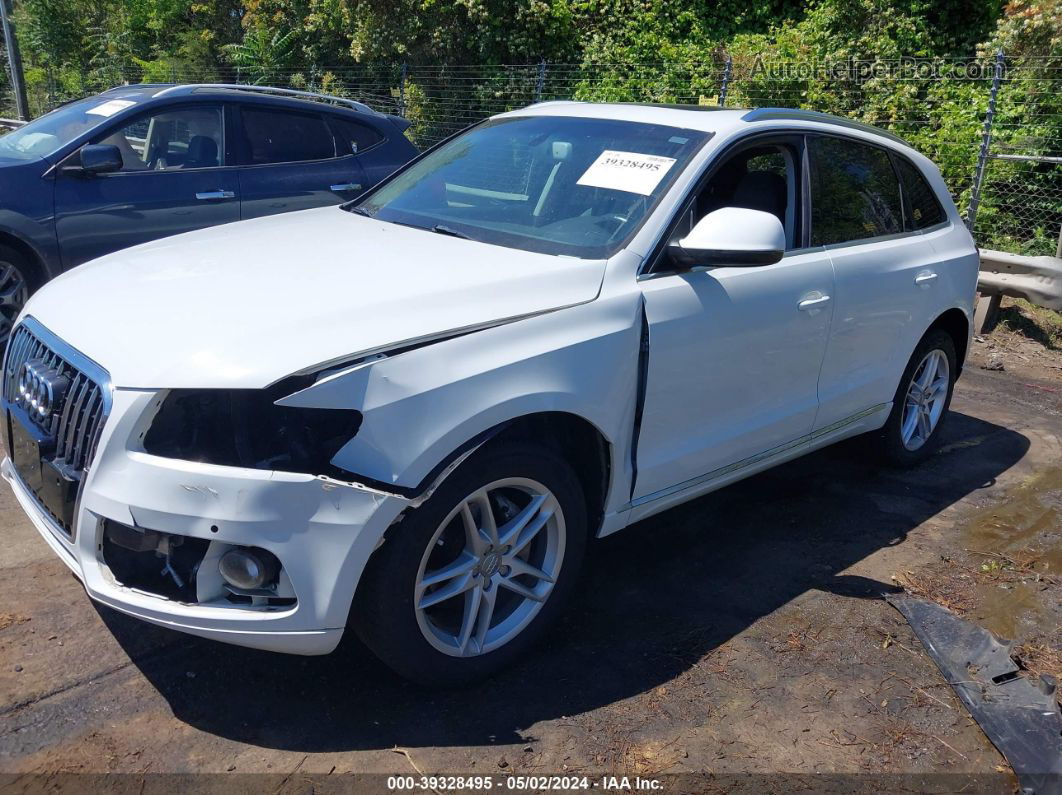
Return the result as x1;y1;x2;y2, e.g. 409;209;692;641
413;478;565;657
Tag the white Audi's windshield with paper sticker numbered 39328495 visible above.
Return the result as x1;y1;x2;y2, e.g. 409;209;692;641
347;116;710;259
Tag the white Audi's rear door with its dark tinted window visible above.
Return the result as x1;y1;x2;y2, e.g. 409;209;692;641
808;136;937;430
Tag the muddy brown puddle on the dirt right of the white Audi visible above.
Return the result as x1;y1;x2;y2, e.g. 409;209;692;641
962;467;1062;639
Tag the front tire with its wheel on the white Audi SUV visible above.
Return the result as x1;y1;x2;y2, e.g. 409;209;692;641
348;443;587;687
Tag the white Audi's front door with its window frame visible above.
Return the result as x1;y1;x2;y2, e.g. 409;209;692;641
634;134;834;502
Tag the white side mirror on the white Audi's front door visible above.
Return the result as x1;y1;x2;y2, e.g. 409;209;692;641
668;207;786;271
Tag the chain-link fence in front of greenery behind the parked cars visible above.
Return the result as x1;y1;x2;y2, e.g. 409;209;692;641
0;52;1062;255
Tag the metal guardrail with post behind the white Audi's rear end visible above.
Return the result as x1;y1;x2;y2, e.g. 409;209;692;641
974;249;1062;333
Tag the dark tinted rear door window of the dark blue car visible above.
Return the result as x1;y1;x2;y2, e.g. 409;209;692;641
241;107;336;166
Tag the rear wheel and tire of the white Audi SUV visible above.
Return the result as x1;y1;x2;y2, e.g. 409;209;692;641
878;330;958;467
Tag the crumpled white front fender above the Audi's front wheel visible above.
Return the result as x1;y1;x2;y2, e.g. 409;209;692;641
277;291;640;511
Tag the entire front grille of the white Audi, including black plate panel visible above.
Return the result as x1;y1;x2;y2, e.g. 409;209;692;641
2;318;108;538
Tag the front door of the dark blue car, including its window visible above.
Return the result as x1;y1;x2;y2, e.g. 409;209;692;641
55;104;240;267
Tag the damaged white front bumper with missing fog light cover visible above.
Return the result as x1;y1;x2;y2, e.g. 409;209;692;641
0;390;410;654
